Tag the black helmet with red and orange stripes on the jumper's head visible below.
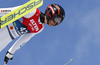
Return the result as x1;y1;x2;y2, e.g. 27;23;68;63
45;4;65;25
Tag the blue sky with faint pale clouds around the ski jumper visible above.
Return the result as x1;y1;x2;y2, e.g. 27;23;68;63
0;0;100;65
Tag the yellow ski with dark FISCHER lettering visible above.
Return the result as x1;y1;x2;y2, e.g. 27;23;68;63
0;0;43;29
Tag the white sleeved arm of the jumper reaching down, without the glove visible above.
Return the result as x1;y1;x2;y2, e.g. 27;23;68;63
8;33;36;54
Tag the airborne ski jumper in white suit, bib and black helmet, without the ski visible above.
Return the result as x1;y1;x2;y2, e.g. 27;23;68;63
0;4;65;65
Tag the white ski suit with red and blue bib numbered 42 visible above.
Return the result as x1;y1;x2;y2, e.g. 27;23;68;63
0;6;44;54
